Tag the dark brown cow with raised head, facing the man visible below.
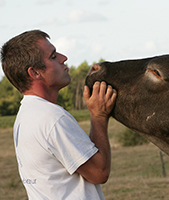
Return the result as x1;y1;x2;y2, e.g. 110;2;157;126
85;55;169;155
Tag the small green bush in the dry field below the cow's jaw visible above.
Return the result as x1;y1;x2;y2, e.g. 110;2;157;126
118;128;148;146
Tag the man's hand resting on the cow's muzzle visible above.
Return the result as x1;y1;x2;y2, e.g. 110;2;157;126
83;81;117;118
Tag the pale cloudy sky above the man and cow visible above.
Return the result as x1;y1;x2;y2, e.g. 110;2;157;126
0;0;169;80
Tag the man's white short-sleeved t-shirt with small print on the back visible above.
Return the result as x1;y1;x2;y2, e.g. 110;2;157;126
14;95;105;200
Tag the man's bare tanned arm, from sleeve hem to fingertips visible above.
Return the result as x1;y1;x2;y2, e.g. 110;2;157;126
77;82;117;184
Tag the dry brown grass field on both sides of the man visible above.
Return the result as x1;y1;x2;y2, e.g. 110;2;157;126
0;119;169;200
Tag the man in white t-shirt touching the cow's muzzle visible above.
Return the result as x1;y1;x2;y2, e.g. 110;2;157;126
1;30;116;200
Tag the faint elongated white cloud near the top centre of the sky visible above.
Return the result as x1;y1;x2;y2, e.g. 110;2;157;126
68;9;106;23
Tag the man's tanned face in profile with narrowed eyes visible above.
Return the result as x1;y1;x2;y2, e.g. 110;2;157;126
37;39;71;91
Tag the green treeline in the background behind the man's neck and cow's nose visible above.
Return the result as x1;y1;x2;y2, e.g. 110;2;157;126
0;59;104;116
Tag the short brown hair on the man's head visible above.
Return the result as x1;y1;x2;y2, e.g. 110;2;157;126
1;30;50;93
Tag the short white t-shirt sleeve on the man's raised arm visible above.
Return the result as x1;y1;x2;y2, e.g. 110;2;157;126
49;115;98;174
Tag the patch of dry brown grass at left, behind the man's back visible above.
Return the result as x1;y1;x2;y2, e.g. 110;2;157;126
0;128;27;200
